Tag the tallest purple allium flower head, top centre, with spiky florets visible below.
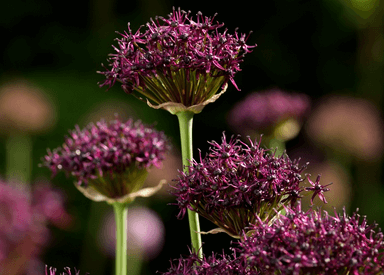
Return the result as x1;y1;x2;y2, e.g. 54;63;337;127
99;8;254;114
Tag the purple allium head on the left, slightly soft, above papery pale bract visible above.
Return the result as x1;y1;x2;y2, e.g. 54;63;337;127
43;117;170;205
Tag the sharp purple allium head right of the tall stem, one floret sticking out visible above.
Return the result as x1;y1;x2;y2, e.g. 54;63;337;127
173;135;326;237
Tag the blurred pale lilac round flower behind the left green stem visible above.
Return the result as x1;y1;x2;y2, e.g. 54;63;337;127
98;207;165;259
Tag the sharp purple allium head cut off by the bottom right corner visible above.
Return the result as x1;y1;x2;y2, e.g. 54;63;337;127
238;205;384;275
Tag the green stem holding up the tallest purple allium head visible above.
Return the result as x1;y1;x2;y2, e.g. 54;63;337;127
176;112;203;258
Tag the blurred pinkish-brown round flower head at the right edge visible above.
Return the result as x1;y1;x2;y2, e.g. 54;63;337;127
306;96;384;161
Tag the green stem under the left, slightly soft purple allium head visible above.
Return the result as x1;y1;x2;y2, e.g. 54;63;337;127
113;202;128;275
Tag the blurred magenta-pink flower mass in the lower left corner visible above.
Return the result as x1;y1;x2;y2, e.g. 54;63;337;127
0;180;71;275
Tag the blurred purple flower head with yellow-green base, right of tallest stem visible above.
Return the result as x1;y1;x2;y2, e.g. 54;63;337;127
228;88;310;141
